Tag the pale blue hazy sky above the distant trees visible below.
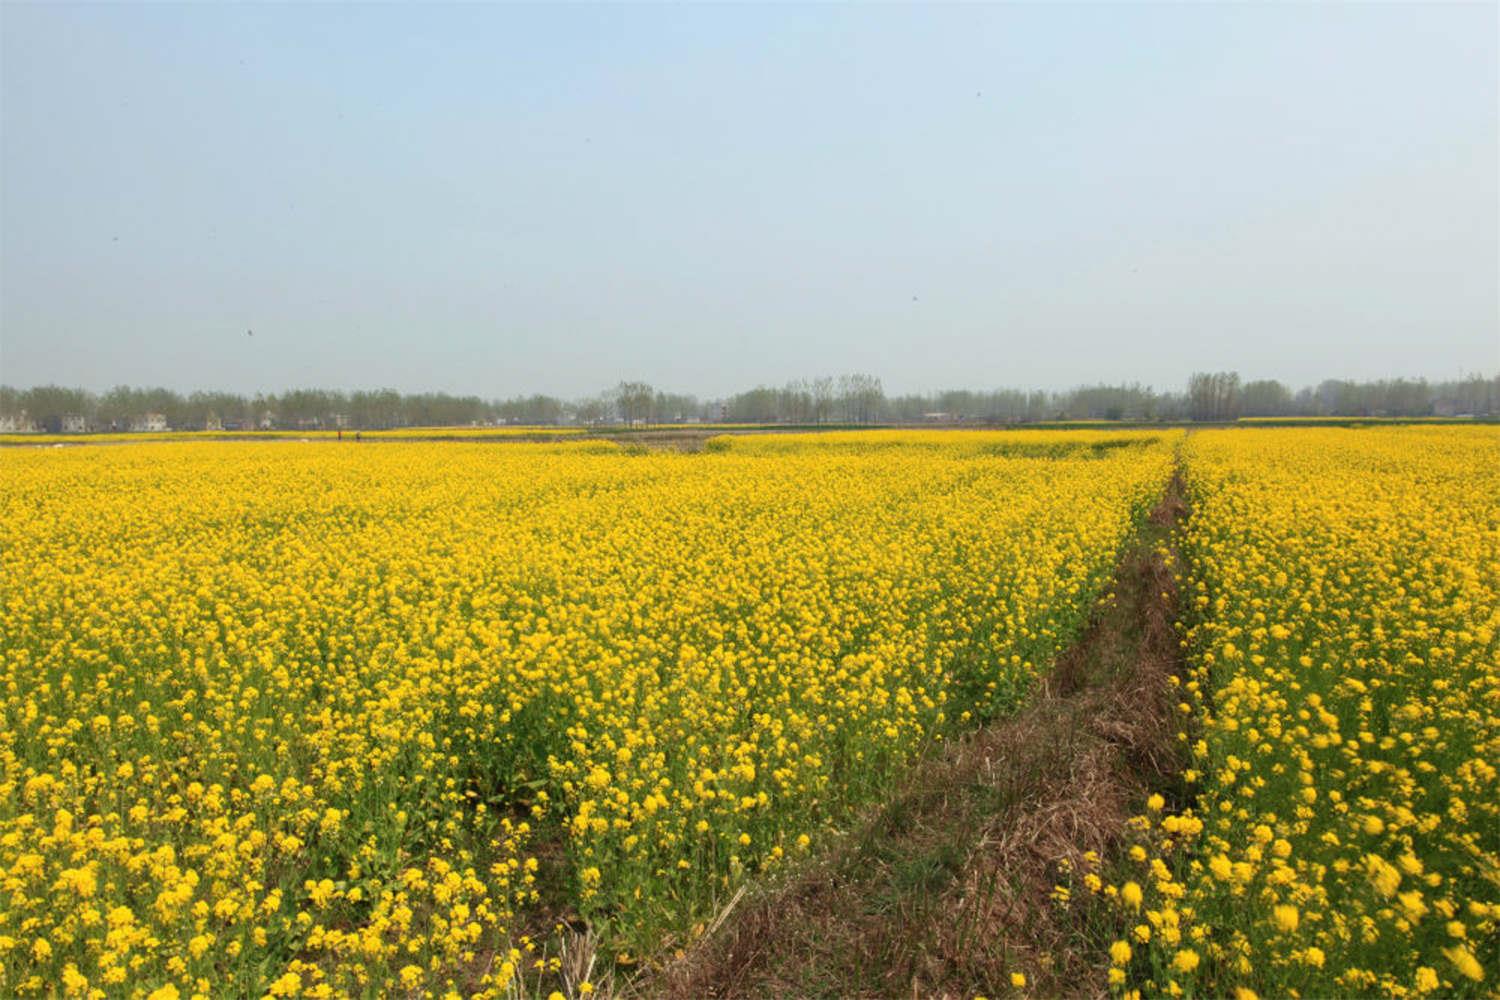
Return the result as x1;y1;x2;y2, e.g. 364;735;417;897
0;3;1500;396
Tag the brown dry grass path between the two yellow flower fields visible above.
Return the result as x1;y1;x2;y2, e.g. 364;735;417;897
651;477;1187;1000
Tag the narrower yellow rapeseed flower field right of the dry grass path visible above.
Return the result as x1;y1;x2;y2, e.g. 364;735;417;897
1112;427;1500;999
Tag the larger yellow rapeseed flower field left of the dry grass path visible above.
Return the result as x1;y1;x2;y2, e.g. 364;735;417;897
0;433;1175;997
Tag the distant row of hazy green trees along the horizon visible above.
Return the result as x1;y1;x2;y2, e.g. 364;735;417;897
0;372;1500;430
